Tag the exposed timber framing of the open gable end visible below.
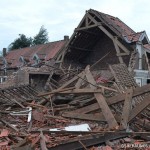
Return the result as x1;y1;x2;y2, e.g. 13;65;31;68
62;10;132;63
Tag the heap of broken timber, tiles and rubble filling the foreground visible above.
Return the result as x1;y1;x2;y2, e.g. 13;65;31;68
0;64;150;150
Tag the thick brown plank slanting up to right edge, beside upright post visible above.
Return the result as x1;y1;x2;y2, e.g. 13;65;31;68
128;95;150;122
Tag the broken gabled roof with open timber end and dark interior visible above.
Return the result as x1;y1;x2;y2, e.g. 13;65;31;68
64;9;149;68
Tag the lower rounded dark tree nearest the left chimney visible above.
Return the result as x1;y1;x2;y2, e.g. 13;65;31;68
8;34;32;51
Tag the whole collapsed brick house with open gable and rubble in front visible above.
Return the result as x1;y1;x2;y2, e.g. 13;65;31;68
0;9;150;150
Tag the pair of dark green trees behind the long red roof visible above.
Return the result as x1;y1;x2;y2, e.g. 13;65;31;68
8;26;48;51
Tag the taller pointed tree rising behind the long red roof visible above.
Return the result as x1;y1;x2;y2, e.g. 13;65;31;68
32;26;48;45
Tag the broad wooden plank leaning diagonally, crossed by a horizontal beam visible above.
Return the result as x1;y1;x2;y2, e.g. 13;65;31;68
85;66;118;129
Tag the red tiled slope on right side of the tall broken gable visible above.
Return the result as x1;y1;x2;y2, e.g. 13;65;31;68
88;9;143;42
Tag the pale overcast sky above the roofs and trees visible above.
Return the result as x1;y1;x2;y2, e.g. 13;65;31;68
0;0;150;50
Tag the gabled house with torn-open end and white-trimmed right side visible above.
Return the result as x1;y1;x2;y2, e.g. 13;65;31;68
63;9;150;86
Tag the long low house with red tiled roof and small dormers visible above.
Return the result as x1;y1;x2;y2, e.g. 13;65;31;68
0;36;69;76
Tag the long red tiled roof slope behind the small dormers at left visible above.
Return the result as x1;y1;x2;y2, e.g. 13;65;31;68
5;40;66;67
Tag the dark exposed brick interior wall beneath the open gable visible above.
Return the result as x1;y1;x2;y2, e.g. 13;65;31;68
64;31;130;69
